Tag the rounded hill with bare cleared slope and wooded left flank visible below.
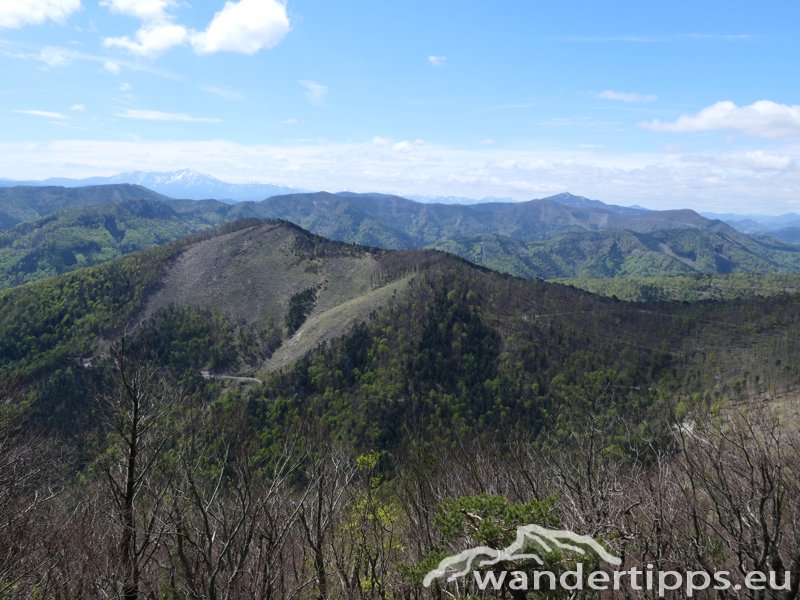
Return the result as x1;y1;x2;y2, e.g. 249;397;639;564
0;221;413;430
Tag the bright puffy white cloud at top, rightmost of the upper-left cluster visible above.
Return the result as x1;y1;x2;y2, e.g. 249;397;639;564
191;0;291;54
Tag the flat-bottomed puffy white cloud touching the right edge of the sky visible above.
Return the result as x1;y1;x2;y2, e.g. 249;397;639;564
640;100;800;139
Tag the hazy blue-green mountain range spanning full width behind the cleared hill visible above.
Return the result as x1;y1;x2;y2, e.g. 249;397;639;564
0;184;800;287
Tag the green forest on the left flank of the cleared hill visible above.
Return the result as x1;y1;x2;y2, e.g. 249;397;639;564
0;218;268;435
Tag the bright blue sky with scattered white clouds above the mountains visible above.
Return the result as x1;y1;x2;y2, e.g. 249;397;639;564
0;0;800;214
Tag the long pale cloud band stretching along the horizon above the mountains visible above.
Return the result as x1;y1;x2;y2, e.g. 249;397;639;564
6;138;800;214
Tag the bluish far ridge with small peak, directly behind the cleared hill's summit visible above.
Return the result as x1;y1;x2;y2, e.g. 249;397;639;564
258;192;715;248
